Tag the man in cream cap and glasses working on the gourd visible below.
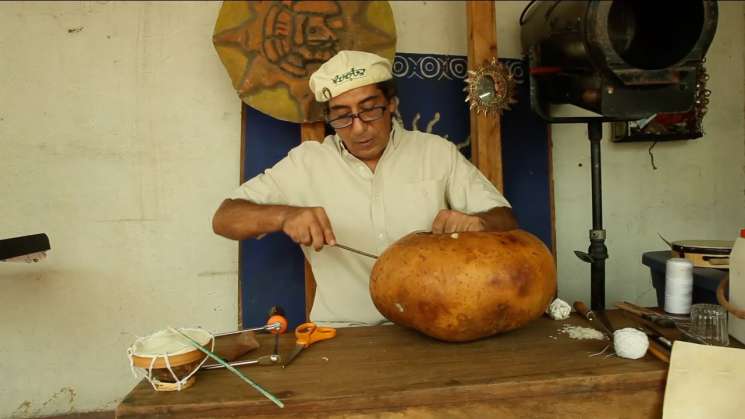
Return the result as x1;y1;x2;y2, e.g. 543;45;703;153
213;51;517;324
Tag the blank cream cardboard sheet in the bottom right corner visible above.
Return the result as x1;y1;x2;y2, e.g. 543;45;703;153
662;341;745;419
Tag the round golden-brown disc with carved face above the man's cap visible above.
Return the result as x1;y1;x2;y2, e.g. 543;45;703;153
212;1;396;122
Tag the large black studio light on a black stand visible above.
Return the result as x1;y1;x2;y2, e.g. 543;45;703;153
520;0;718;310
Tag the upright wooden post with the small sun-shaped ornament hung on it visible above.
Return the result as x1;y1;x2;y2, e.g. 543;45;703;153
466;1;504;191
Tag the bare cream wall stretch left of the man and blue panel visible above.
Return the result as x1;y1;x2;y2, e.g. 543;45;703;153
0;1;240;417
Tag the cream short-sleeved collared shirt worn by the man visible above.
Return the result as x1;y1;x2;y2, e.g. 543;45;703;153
230;121;510;326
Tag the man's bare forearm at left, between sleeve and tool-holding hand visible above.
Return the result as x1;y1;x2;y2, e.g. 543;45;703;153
212;199;292;240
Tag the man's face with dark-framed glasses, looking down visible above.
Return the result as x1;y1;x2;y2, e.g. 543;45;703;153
329;84;396;170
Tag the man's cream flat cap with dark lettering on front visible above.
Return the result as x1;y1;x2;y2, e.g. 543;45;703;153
309;51;393;102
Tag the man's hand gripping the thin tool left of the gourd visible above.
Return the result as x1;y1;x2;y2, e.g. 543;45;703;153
282;207;336;251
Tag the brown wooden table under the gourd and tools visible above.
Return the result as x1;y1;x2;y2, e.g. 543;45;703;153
116;311;667;419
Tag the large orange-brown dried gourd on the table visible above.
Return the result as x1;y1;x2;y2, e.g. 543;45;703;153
370;230;556;342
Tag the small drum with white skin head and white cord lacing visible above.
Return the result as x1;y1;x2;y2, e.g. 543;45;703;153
127;328;215;391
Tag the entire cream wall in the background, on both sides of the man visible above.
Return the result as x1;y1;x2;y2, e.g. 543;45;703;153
0;1;745;417
